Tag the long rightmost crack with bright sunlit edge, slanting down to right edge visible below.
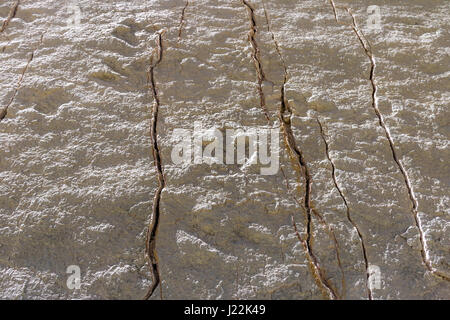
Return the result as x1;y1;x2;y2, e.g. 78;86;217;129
330;0;450;281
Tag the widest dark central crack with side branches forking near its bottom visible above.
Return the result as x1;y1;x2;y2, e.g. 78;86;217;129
262;1;345;300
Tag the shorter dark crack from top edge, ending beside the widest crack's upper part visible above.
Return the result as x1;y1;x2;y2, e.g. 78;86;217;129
242;0;270;121
